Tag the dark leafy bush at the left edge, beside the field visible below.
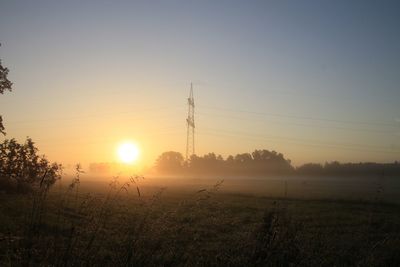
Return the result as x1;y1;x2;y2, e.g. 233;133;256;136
0;138;62;192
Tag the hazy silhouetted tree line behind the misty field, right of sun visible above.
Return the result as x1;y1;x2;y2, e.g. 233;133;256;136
154;149;400;176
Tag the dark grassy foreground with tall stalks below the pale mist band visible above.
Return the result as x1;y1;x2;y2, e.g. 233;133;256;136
0;175;400;266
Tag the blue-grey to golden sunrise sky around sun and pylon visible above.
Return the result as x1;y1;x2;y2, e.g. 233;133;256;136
0;0;400;170
